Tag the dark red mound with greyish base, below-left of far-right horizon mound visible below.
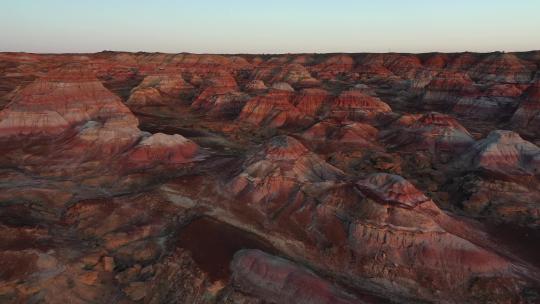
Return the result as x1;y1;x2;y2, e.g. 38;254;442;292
421;71;477;109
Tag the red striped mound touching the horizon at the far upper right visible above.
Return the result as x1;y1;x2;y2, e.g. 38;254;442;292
468;53;536;83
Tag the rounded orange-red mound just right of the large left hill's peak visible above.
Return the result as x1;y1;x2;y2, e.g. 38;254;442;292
127;74;194;106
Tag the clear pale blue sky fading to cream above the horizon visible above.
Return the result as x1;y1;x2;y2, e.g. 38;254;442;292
0;0;540;53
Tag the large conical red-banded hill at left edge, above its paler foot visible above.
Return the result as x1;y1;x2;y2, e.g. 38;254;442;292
0;65;138;136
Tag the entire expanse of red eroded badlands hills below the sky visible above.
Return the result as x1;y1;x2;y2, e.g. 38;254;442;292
0;51;540;304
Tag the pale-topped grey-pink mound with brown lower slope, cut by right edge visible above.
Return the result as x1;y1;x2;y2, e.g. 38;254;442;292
455;130;540;227
